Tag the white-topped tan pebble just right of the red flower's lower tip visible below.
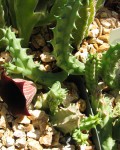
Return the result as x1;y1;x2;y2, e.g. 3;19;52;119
28;110;41;120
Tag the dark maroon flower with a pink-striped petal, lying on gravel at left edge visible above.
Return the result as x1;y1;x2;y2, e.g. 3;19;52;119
0;72;37;115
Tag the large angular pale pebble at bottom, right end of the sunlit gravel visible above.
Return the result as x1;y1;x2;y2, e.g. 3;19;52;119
39;133;53;146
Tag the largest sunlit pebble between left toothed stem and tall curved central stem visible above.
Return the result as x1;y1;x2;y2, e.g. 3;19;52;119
40;52;55;62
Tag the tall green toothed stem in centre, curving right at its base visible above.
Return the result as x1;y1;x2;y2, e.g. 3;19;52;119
51;0;85;74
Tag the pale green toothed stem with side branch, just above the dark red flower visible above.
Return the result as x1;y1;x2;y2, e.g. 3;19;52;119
0;28;67;86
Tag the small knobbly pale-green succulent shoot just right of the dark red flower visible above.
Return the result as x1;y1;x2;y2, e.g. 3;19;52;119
34;81;67;115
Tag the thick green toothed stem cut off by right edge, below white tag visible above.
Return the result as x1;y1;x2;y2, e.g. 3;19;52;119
101;44;120;89
